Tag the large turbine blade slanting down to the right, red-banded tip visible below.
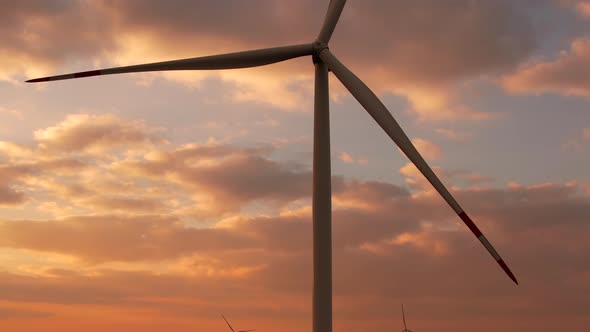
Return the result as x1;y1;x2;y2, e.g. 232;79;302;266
319;49;518;284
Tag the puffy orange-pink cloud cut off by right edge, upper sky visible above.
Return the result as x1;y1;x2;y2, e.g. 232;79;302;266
502;38;590;96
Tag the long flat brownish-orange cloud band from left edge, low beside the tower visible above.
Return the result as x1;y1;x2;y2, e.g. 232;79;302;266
0;215;260;263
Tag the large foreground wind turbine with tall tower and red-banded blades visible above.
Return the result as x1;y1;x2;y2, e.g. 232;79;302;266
27;0;518;332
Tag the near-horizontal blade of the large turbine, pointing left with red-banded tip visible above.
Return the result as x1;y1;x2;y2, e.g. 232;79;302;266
27;44;313;83
